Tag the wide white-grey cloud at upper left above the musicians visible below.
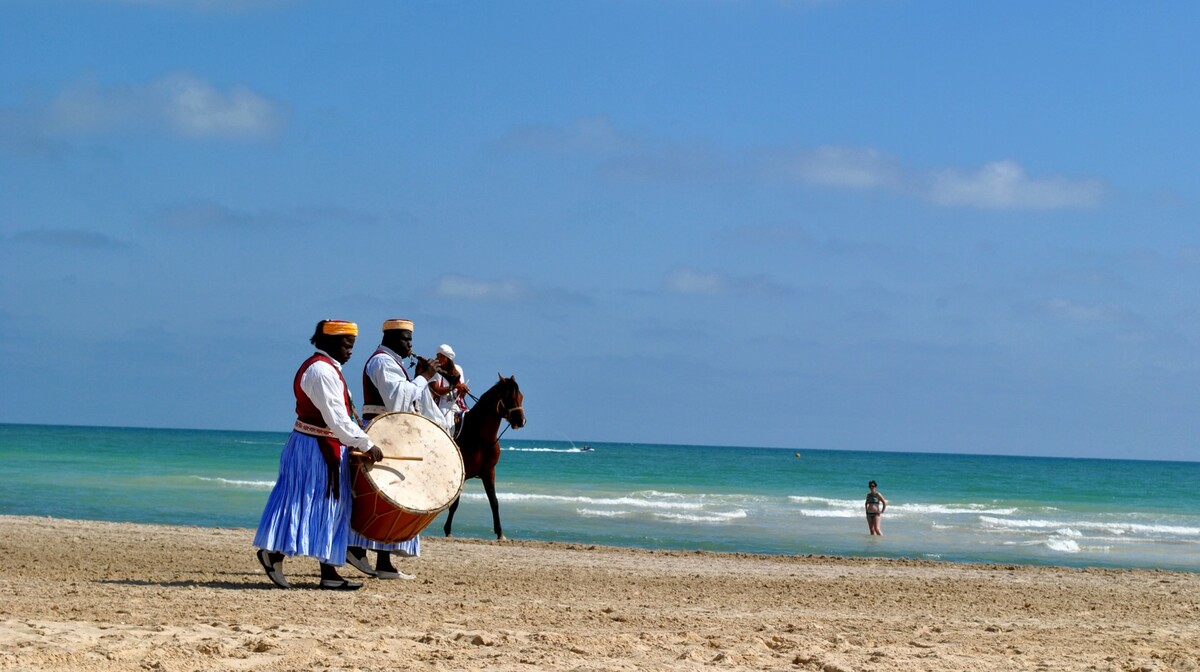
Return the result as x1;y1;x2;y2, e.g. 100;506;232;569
48;73;287;139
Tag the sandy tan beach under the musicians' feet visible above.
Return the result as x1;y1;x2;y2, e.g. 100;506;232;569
0;517;1200;672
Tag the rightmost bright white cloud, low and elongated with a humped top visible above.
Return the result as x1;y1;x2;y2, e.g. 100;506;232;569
928;161;1105;210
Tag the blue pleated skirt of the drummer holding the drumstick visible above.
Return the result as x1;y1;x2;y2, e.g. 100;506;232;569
254;432;354;565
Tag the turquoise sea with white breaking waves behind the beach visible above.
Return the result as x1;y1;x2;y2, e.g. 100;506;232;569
0;425;1200;571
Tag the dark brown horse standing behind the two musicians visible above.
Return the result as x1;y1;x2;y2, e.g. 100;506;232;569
442;376;524;540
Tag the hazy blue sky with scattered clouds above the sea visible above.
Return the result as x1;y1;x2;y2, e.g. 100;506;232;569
0;0;1200;460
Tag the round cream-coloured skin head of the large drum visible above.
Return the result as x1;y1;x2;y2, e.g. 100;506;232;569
364;413;463;514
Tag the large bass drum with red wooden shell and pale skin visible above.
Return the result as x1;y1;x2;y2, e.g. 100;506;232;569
350;413;463;544
